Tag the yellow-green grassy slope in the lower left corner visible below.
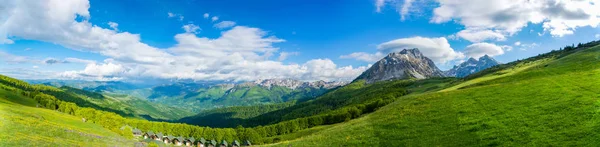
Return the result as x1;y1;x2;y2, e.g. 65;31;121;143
0;89;134;146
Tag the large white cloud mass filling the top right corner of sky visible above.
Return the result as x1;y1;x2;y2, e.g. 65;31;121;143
431;0;600;37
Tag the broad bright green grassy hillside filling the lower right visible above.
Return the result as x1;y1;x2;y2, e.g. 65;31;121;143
273;46;600;146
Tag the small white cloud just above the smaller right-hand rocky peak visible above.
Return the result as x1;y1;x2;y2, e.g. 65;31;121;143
464;43;504;58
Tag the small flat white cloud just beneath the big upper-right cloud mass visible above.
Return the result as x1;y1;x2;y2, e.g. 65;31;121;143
456;29;506;42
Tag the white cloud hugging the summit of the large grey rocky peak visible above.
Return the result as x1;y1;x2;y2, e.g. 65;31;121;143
377;37;464;64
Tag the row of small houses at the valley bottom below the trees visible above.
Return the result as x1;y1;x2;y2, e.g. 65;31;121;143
132;129;252;147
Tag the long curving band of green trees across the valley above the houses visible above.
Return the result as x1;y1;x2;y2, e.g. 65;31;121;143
0;75;408;144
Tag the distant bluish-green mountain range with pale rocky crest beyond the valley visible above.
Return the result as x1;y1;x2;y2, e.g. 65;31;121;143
148;79;346;111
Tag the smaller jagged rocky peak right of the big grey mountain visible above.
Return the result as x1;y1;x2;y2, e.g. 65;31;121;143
444;55;501;78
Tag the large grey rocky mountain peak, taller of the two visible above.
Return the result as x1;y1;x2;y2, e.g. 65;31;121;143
356;49;444;83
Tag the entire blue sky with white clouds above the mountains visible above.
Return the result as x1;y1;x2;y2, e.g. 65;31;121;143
0;0;600;81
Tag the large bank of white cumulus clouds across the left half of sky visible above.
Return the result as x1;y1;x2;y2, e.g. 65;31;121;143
0;0;366;81
